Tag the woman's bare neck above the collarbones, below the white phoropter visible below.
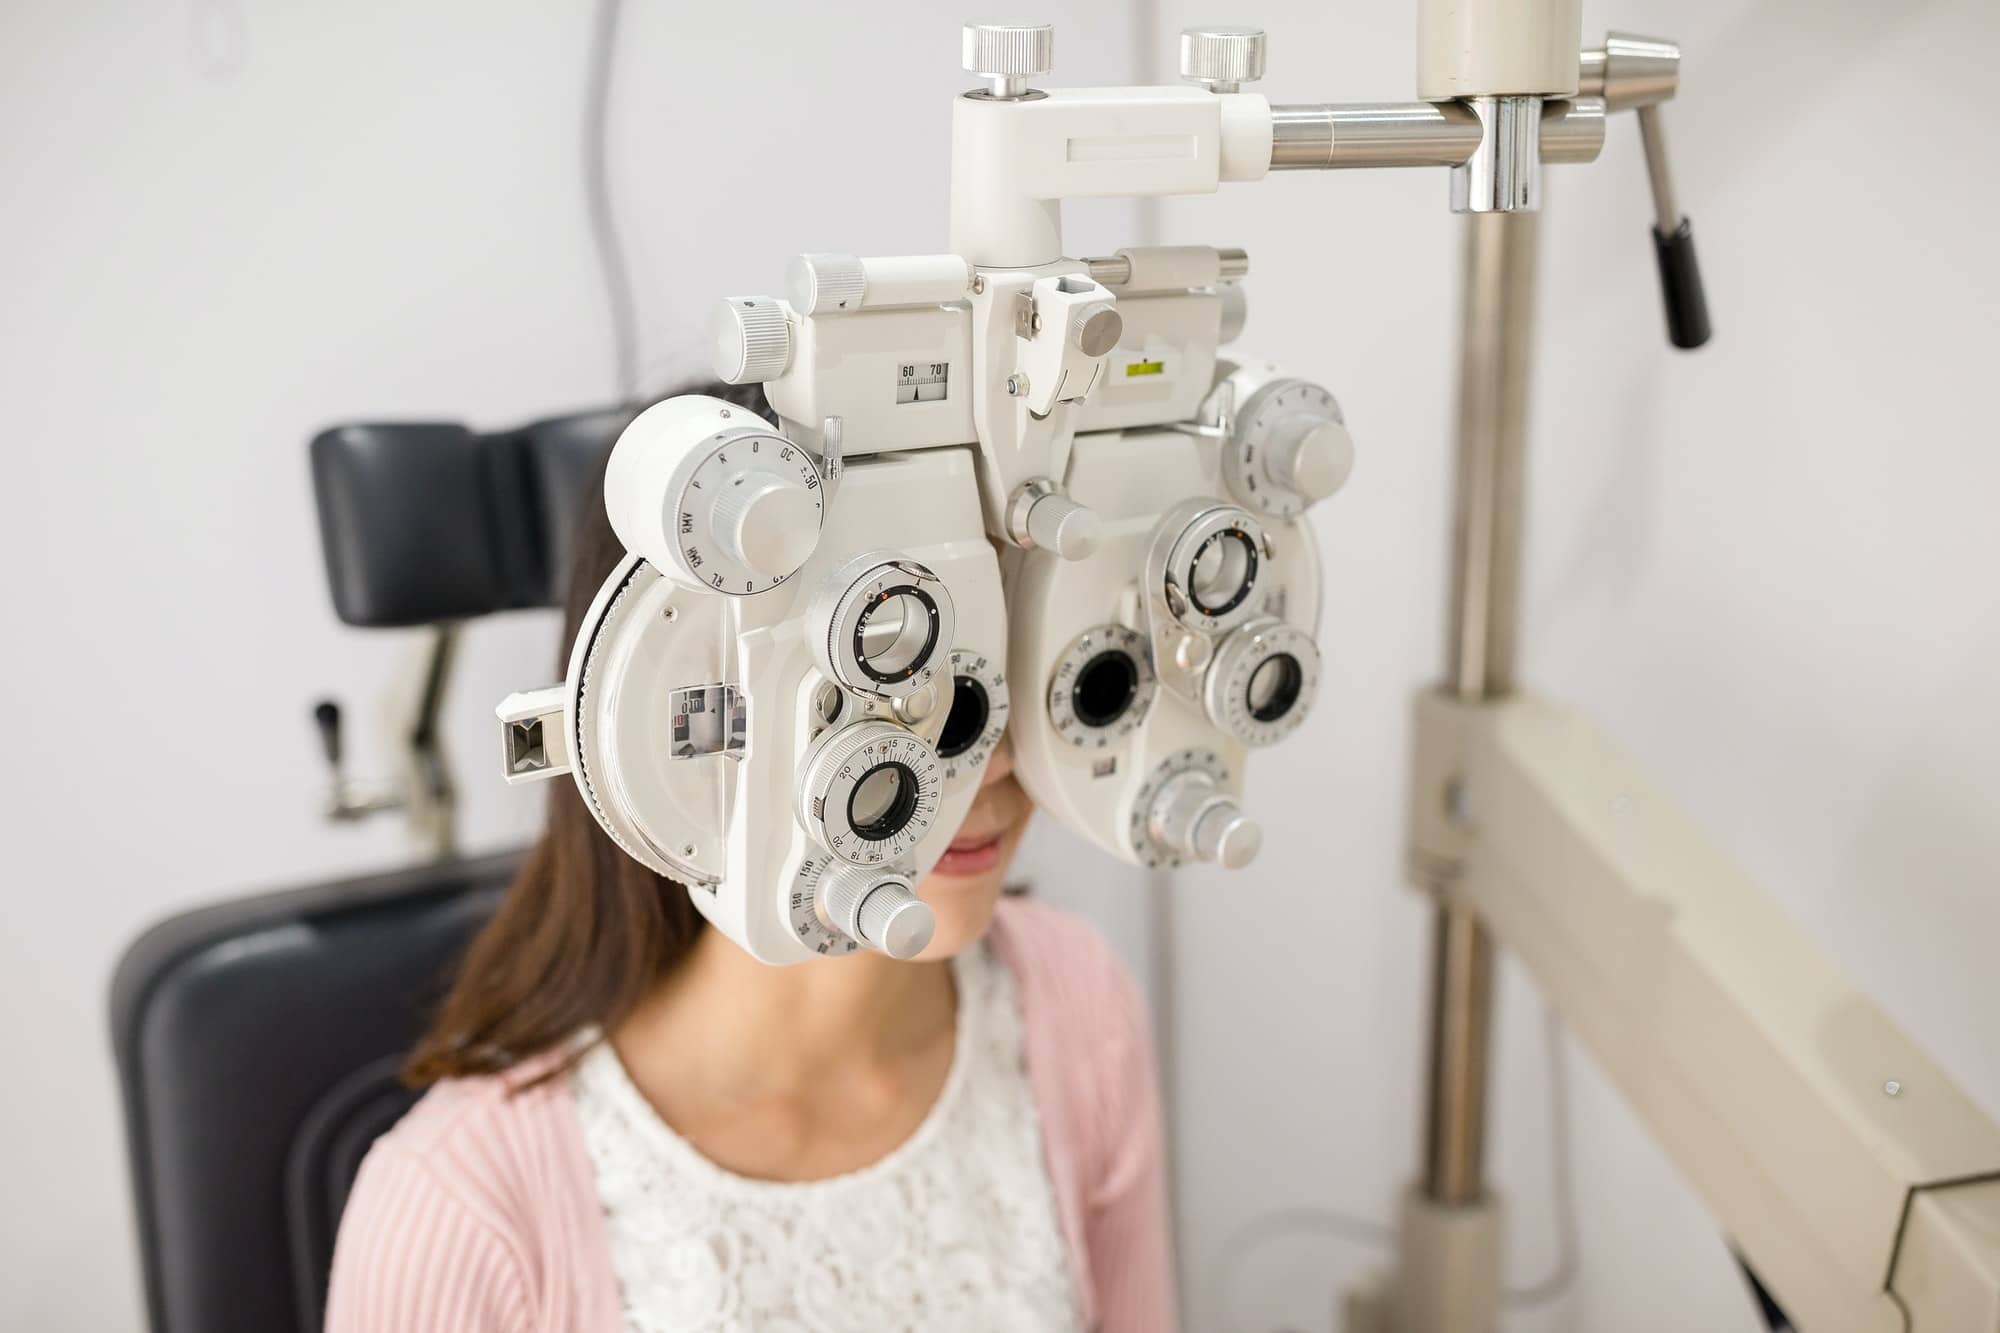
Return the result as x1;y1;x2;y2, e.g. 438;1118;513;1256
612;931;956;1103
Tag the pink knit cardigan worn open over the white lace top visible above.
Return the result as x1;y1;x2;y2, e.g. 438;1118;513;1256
326;899;1174;1333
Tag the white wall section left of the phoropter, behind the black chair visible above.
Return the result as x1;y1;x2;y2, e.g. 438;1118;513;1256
0;0;1136;1331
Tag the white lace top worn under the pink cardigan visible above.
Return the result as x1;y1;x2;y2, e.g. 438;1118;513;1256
570;932;1080;1333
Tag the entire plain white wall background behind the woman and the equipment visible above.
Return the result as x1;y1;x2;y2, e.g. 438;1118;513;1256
0;0;2000;1333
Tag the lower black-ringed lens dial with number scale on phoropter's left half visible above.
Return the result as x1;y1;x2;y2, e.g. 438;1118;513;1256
798;719;944;867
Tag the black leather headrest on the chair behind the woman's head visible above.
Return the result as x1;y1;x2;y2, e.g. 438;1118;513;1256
312;408;632;626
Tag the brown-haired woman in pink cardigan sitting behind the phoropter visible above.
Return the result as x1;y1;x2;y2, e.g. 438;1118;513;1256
328;378;1174;1333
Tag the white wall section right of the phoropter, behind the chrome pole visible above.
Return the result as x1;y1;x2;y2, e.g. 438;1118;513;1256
1158;0;2000;1333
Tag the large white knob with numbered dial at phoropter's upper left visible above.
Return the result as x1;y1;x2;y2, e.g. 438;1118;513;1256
604;394;826;596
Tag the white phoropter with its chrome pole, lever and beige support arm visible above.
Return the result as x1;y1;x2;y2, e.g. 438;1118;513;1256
488;10;2000;1333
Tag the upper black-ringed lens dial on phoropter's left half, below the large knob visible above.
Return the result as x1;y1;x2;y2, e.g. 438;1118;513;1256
810;550;954;699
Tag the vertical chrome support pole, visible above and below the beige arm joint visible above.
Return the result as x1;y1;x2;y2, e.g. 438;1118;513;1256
1424;212;1536;1205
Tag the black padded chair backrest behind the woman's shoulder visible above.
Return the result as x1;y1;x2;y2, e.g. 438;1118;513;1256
112;853;520;1333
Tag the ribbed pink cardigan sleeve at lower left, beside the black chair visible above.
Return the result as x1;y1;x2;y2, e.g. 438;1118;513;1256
326;1145;530;1333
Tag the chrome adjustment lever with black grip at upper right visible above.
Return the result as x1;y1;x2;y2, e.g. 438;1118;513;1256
1578;32;1710;348
